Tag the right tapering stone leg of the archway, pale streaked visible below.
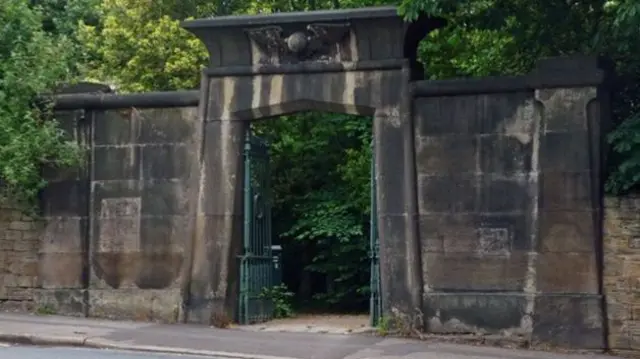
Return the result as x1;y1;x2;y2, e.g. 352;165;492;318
374;68;423;330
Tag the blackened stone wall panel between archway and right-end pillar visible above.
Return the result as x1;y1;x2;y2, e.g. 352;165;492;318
416;91;540;335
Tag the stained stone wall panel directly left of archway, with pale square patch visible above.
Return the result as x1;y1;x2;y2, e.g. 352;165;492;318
89;108;200;321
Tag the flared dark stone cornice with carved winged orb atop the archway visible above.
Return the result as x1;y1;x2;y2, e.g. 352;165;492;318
183;6;444;67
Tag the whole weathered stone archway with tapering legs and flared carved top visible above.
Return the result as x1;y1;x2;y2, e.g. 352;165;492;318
184;7;442;322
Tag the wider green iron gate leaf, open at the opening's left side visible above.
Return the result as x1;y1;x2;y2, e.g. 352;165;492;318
238;129;274;324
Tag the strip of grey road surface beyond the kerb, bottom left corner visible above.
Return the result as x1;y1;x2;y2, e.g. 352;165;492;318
0;344;215;359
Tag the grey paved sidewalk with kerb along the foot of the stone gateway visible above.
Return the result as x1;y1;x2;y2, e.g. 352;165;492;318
0;314;613;359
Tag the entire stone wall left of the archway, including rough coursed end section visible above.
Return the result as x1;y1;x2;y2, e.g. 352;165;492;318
0;86;200;322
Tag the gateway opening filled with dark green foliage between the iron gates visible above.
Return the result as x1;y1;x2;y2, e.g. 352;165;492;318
240;112;379;329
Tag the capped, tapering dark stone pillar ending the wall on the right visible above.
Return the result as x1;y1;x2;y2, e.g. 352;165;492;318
533;57;608;349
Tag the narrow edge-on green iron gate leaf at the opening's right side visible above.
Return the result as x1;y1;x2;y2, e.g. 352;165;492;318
369;141;382;327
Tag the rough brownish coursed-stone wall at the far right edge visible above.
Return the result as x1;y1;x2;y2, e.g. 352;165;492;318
604;195;640;352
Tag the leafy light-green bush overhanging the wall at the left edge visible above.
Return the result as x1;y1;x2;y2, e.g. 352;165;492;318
0;0;86;208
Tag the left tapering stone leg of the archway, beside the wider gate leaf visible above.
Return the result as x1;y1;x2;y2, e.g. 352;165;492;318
186;76;248;324
